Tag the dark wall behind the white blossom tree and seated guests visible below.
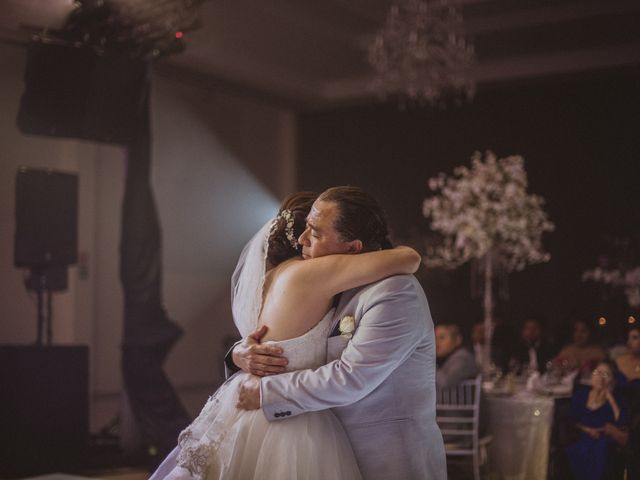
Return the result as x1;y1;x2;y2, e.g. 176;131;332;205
298;68;640;344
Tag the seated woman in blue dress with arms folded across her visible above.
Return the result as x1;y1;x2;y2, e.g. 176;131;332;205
566;361;629;480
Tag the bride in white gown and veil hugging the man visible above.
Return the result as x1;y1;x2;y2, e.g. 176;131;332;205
151;192;420;480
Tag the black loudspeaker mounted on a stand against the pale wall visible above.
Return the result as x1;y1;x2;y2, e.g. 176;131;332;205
14;168;78;268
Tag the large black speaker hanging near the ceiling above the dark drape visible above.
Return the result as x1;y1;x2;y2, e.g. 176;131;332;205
17;41;148;145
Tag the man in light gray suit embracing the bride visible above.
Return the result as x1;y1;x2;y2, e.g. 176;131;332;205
231;187;446;480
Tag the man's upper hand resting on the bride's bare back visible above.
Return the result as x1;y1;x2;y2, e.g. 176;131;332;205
231;325;288;377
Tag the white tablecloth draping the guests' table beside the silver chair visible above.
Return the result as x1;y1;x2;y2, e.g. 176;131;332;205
481;390;554;480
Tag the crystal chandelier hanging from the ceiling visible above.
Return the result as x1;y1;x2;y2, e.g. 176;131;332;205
368;0;475;104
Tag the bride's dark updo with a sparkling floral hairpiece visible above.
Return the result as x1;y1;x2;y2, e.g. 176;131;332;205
267;192;318;267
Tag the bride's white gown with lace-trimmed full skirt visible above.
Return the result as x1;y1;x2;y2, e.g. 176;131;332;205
151;311;361;480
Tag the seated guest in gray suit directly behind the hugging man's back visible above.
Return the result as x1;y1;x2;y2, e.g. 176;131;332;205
435;324;478;388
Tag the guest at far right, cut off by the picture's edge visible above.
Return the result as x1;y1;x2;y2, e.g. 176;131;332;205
616;324;640;478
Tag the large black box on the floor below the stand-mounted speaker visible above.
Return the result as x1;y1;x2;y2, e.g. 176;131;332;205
0;346;89;478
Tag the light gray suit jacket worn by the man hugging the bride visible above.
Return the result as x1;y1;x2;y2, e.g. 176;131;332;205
262;275;446;480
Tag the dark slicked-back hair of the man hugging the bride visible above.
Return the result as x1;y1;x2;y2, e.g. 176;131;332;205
318;186;391;252
